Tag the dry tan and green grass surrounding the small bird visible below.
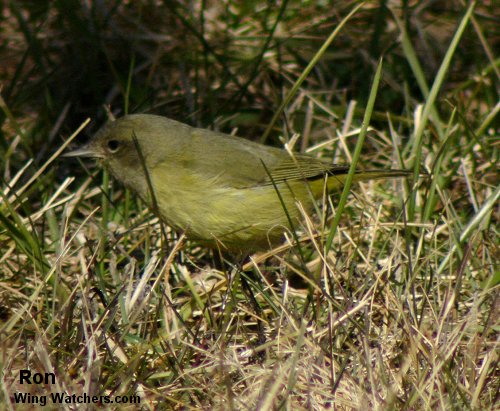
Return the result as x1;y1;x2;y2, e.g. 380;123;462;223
0;0;500;410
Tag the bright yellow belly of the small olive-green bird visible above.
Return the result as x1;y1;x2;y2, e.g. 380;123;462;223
157;177;312;252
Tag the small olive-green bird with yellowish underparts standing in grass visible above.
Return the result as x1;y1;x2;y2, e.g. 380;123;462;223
65;114;411;253
